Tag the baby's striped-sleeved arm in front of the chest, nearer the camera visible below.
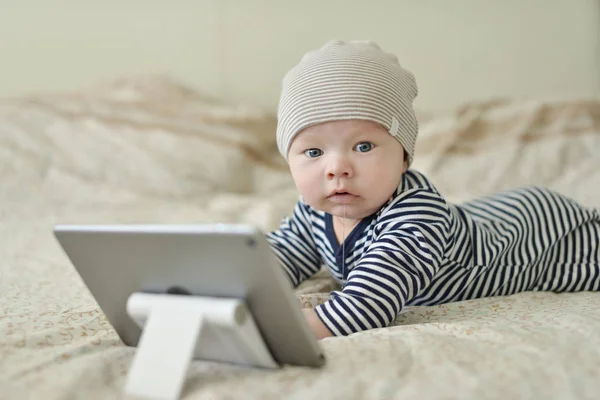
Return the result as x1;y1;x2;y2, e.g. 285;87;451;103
315;189;450;335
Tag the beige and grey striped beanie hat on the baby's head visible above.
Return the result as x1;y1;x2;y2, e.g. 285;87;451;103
277;40;418;165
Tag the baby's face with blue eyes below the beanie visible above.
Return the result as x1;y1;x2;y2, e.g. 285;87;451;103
288;120;406;220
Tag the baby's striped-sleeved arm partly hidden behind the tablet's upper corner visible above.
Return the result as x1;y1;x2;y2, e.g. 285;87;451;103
266;200;322;287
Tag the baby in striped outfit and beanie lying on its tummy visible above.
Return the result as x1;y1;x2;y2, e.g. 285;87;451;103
267;41;600;339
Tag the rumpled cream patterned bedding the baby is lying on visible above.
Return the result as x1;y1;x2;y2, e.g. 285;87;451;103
0;78;600;399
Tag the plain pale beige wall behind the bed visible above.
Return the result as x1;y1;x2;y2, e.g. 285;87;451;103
0;0;600;109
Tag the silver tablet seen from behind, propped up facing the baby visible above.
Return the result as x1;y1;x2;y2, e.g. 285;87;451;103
54;224;325;367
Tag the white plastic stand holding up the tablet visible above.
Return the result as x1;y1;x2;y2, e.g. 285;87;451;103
125;293;278;400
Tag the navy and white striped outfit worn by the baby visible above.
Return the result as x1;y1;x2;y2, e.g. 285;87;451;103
267;170;600;335
